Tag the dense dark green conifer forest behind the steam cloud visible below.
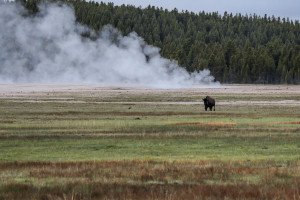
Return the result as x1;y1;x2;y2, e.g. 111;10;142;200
17;0;300;84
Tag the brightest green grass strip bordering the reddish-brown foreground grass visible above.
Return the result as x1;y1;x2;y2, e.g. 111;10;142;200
0;136;300;162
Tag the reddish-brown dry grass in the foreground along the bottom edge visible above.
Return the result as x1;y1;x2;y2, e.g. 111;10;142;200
0;160;300;199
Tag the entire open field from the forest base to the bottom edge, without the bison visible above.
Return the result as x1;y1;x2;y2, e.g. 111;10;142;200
0;85;300;199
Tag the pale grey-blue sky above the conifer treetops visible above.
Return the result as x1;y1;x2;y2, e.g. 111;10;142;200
96;0;300;20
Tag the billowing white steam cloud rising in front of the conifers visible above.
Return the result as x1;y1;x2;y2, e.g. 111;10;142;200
0;3;219;88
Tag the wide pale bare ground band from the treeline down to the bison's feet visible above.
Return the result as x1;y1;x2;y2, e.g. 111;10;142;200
0;84;300;106
